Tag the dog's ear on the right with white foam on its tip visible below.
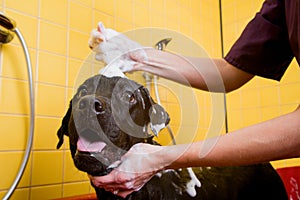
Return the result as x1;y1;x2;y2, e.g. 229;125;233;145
142;88;170;136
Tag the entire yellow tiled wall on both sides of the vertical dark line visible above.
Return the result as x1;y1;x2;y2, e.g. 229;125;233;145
0;0;300;200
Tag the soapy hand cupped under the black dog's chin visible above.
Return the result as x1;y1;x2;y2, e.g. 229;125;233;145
89;143;165;198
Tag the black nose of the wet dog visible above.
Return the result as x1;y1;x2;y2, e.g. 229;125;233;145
78;96;105;114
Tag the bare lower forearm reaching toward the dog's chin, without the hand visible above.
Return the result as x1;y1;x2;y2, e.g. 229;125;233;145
161;104;300;168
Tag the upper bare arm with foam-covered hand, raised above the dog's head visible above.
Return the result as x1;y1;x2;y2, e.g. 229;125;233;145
89;22;253;92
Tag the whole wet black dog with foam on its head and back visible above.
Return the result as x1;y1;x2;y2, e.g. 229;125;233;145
57;75;287;200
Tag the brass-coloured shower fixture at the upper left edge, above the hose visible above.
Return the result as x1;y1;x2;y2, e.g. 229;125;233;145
0;12;16;44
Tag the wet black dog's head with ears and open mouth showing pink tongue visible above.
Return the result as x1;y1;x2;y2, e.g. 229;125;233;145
57;75;169;176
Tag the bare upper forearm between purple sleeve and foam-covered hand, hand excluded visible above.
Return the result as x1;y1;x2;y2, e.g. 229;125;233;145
133;48;253;92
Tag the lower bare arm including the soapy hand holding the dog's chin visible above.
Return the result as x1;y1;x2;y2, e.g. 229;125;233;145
90;104;300;197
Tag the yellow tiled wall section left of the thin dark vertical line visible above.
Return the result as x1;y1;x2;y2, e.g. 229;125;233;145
0;0;220;200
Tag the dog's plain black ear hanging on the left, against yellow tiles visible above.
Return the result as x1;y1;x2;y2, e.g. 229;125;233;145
56;100;72;149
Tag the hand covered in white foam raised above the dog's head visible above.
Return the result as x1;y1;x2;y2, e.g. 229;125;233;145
89;22;147;72
